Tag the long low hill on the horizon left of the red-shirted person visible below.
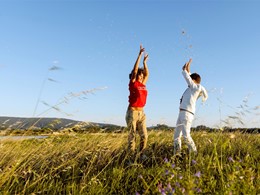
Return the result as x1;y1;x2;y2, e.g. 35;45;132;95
0;116;120;130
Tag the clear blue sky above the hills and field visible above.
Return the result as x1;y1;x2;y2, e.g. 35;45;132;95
0;0;260;127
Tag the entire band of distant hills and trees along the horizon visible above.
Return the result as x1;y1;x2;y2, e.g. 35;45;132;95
0;116;260;133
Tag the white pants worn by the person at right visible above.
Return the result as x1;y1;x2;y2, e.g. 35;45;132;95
173;111;197;154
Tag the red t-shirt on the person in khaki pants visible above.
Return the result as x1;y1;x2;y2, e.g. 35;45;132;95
128;81;147;107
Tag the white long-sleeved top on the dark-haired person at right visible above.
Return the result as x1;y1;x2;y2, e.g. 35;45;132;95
180;70;208;114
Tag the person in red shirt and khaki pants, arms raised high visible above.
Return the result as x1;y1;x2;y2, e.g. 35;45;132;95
126;45;149;152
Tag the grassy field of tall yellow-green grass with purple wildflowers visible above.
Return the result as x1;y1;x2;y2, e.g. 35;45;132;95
0;131;260;195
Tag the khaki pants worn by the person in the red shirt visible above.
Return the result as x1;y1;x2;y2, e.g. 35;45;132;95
125;109;148;151
